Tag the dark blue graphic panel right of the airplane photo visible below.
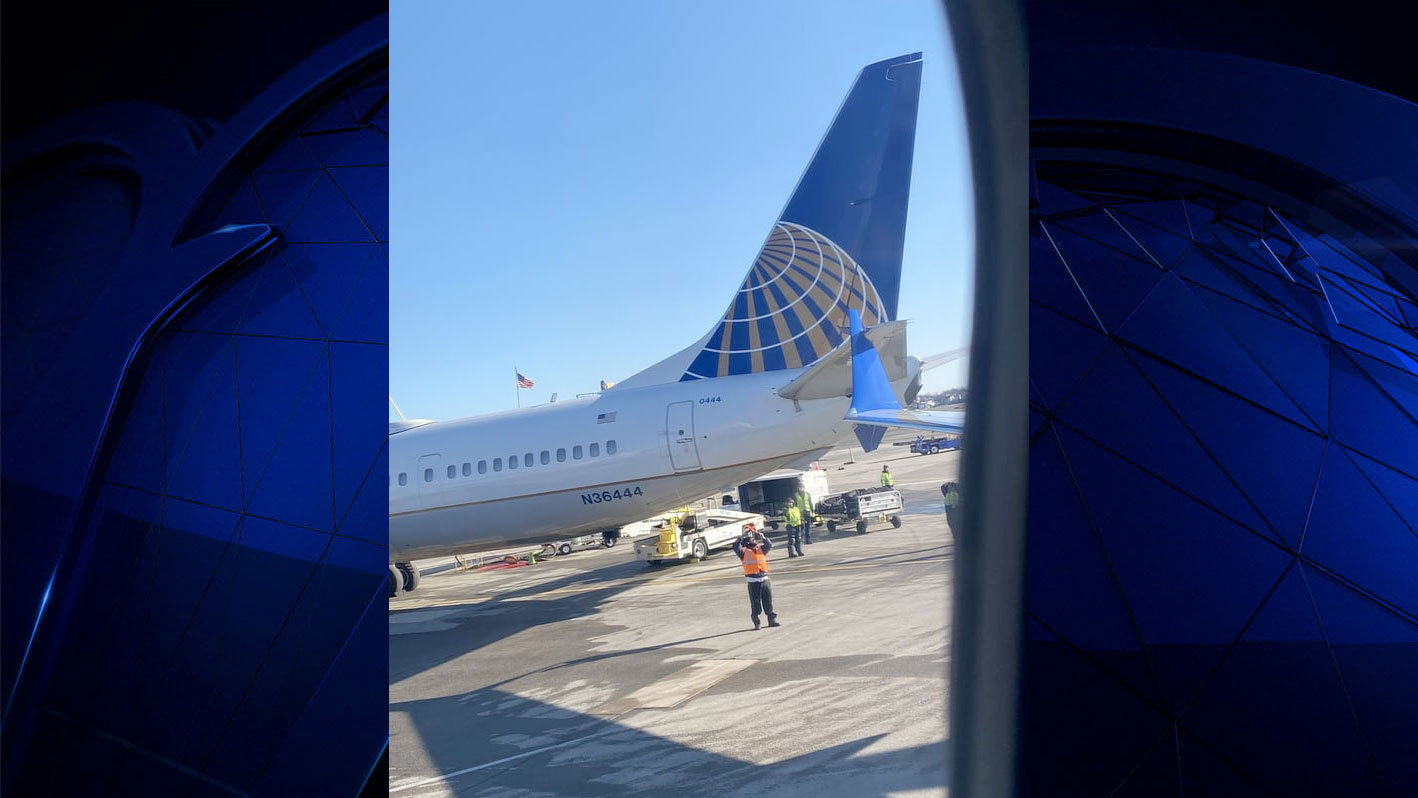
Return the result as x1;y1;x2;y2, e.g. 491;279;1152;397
1018;1;1418;795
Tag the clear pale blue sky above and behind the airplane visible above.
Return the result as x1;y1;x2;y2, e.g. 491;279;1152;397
390;0;974;420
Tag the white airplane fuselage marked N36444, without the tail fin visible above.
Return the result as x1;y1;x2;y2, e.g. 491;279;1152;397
389;370;901;561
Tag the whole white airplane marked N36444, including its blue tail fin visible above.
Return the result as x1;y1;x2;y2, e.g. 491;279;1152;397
389;52;922;564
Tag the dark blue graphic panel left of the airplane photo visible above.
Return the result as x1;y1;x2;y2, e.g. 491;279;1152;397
0;1;389;795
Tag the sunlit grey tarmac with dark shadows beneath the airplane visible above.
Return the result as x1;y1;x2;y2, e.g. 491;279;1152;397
389;432;960;798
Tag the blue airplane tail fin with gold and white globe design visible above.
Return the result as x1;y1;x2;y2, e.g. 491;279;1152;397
621;52;922;387
